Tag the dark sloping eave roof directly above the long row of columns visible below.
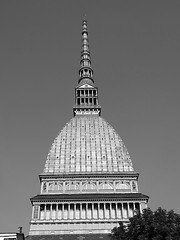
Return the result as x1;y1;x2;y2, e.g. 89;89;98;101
30;193;149;201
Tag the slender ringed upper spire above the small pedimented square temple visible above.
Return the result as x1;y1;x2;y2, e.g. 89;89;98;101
79;15;94;83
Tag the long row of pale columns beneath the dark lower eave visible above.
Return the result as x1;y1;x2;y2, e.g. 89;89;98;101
33;202;140;220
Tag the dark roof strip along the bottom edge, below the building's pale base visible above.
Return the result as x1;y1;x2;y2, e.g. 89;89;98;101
26;234;110;240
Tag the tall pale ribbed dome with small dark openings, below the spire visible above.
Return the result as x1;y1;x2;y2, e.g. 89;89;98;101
44;115;134;174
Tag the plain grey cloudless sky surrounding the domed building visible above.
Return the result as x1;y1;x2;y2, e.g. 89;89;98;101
0;0;180;234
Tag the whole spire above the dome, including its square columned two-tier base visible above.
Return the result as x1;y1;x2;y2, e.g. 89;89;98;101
73;16;101;116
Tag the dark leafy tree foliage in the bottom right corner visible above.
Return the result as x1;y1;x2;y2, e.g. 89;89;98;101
111;208;180;240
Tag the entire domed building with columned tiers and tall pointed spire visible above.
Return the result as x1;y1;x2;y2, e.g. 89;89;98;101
29;19;148;236
